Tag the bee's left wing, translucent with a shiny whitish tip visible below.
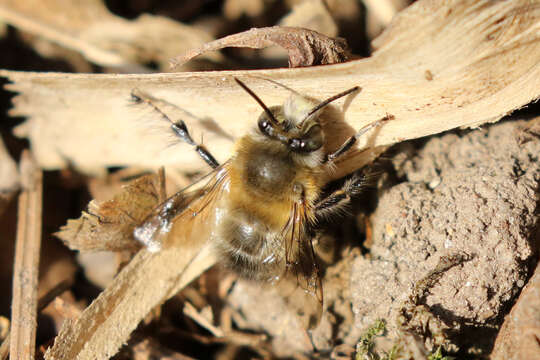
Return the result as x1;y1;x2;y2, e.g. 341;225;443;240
133;164;228;252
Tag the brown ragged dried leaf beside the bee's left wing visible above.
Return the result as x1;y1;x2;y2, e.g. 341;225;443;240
55;175;161;251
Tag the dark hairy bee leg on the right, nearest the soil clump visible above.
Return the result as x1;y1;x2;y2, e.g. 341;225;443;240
315;175;366;220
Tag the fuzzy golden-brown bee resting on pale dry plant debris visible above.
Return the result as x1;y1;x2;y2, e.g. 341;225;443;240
132;78;390;329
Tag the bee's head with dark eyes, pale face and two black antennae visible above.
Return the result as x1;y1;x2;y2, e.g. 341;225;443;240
235;78;360;153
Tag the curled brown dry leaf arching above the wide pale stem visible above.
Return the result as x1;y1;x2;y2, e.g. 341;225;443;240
171;26;347;67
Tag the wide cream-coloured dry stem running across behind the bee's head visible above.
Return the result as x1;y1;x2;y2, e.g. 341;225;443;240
0;0;540;177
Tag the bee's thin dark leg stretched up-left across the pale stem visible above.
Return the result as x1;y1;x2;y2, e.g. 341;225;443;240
131;89;219;169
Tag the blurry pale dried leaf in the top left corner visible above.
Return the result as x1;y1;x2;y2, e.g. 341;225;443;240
0;0;221;72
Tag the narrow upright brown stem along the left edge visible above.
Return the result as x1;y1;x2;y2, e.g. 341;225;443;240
10;151;43;359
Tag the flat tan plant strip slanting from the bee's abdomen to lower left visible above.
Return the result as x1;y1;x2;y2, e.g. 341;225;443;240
45;244;216;360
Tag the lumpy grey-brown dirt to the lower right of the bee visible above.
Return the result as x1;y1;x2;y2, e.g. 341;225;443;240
230;116;540;356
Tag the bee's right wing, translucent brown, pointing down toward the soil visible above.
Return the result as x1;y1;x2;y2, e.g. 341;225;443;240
278;204;323;329
